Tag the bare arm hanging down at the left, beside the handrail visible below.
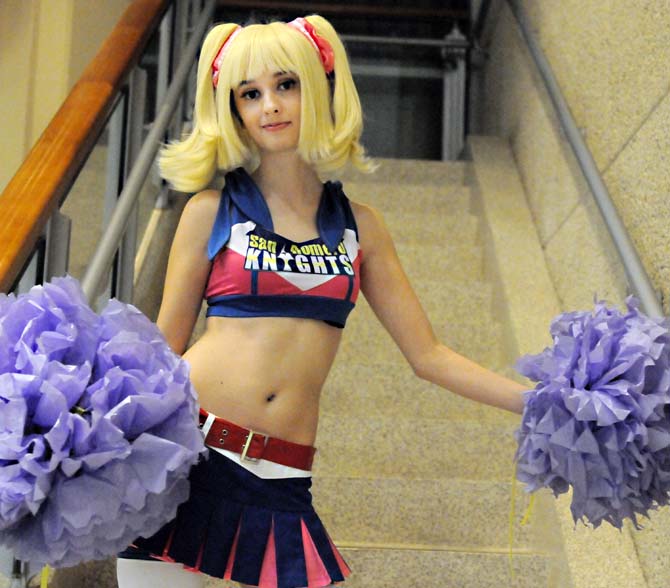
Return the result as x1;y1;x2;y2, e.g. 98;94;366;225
156;190;219;354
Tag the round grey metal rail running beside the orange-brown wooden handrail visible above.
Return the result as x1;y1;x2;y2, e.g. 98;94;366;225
81;0;216;301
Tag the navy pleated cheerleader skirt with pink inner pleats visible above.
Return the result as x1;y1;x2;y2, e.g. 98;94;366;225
119;449;350;588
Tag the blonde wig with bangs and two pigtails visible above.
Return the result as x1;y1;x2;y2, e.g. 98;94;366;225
159;15;373;192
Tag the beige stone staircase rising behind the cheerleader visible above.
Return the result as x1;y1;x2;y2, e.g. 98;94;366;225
42;142;569;588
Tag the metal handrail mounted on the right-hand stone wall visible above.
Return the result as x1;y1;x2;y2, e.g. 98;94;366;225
507;0;663;317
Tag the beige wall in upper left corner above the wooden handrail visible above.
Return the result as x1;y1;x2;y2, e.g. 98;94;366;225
0;0;131;191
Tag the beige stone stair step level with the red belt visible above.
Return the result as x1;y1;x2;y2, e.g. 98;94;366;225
314;414;516;482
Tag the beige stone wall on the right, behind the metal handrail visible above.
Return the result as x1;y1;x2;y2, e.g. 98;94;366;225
480;0;670;588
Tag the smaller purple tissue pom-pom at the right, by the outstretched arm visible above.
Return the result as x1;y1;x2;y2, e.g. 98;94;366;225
516;298;670;528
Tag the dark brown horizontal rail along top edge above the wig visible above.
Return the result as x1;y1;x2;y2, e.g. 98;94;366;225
218;0;470;19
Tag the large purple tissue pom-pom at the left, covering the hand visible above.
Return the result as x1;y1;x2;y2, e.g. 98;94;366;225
0;278;204;567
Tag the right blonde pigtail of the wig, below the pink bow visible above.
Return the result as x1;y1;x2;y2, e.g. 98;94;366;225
305;14;375;173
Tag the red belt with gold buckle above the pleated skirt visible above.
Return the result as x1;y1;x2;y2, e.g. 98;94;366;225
200;409;316;471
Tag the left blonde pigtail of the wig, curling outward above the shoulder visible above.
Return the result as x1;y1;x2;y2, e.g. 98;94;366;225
158;24;240;192
